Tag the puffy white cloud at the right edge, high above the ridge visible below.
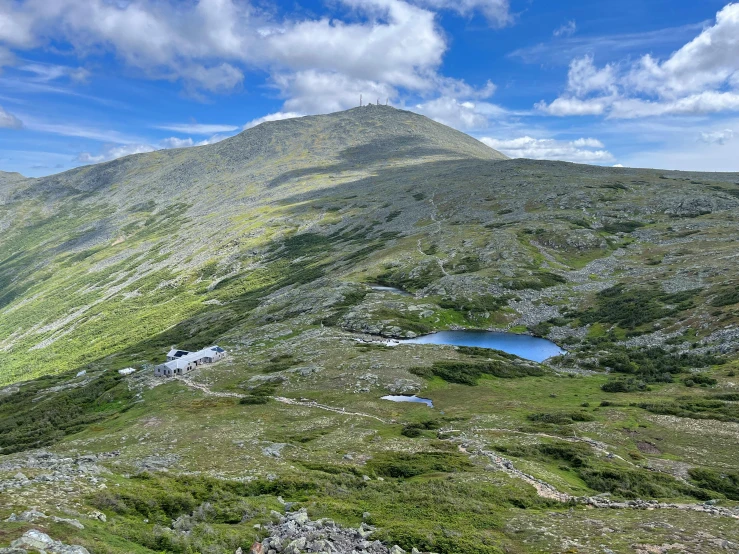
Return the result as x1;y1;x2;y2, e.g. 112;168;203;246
536;3;739;119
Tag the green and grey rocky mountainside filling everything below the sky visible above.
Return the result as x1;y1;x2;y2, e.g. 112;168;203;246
0;106;739;554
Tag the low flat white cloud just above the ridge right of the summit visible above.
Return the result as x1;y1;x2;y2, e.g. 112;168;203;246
480;136;613;164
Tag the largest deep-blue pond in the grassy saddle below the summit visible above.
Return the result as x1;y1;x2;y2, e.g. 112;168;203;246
401;331;564;362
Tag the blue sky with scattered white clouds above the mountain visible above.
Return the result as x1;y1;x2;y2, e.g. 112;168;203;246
0;0;739;176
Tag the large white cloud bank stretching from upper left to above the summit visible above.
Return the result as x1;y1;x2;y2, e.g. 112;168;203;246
0;0;502;120
